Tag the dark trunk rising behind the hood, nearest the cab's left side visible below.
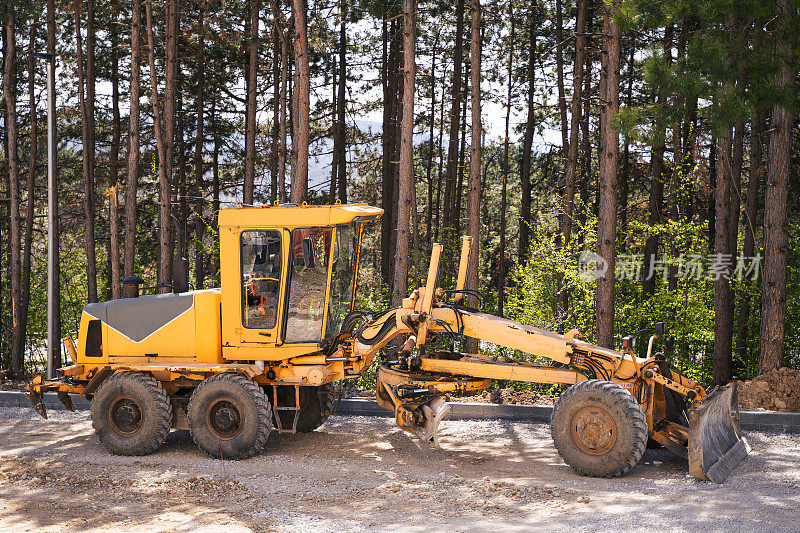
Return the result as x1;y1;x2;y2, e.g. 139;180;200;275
194;6;206;290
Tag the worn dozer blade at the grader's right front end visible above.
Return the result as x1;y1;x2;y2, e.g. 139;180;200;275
689;383;750;483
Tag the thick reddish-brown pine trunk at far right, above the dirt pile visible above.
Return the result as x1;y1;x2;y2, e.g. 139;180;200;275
758;0;797;374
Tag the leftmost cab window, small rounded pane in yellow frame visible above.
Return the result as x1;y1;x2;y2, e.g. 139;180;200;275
241;230;281;329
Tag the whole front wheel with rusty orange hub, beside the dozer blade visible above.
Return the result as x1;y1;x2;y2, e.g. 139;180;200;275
550;379;647;477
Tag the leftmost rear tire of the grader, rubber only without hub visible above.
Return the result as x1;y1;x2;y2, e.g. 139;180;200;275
91;372;172;455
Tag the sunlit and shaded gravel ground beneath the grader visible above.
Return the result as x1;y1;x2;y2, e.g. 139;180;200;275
0;409;800;533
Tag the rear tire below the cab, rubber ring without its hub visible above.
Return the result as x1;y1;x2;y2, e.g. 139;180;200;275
186;373;272;459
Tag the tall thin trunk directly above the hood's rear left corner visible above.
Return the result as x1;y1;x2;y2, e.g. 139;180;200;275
74;2;97;302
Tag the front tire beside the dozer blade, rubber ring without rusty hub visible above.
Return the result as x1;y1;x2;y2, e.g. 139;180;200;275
550;379;648;477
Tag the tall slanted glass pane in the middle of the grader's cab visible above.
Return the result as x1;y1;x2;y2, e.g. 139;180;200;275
284;227;333;343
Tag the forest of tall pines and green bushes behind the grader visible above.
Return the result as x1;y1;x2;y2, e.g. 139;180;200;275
0;0;800;390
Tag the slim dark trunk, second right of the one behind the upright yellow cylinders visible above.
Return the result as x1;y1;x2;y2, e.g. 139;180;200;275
520;0;539;265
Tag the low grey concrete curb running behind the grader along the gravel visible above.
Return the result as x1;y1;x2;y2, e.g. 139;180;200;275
0;391;800;433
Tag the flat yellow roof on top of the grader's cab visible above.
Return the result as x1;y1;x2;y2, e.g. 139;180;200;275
219;203;383;228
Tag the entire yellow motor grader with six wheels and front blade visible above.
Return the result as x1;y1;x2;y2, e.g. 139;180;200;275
28;203;749;482
